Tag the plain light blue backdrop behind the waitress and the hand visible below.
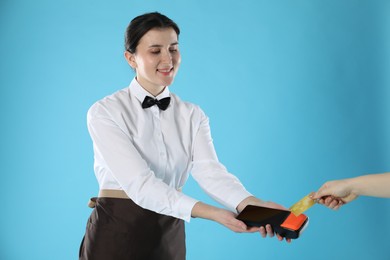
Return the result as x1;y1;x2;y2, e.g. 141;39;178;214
0;0;390;260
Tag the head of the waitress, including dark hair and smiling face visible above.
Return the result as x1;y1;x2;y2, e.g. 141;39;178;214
125;13;181;96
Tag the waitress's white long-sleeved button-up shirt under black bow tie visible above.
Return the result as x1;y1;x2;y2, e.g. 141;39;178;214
87;79;251;221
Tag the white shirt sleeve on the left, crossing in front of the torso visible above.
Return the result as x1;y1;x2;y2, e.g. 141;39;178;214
87;104;197;222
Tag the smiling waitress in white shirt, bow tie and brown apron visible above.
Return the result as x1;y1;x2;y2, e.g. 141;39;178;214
80;13;283;260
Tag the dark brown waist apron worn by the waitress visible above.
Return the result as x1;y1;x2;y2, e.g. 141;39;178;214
79;197;186;260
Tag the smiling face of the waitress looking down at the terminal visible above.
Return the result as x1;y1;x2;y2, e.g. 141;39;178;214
125;28;181;96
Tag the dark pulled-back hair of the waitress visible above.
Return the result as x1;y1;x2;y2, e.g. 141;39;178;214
125;12;180;53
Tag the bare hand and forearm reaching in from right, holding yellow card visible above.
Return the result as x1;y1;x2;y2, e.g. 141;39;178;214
312;172;390;210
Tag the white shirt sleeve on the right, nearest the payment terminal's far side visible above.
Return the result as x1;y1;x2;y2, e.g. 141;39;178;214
191;108;252;211
